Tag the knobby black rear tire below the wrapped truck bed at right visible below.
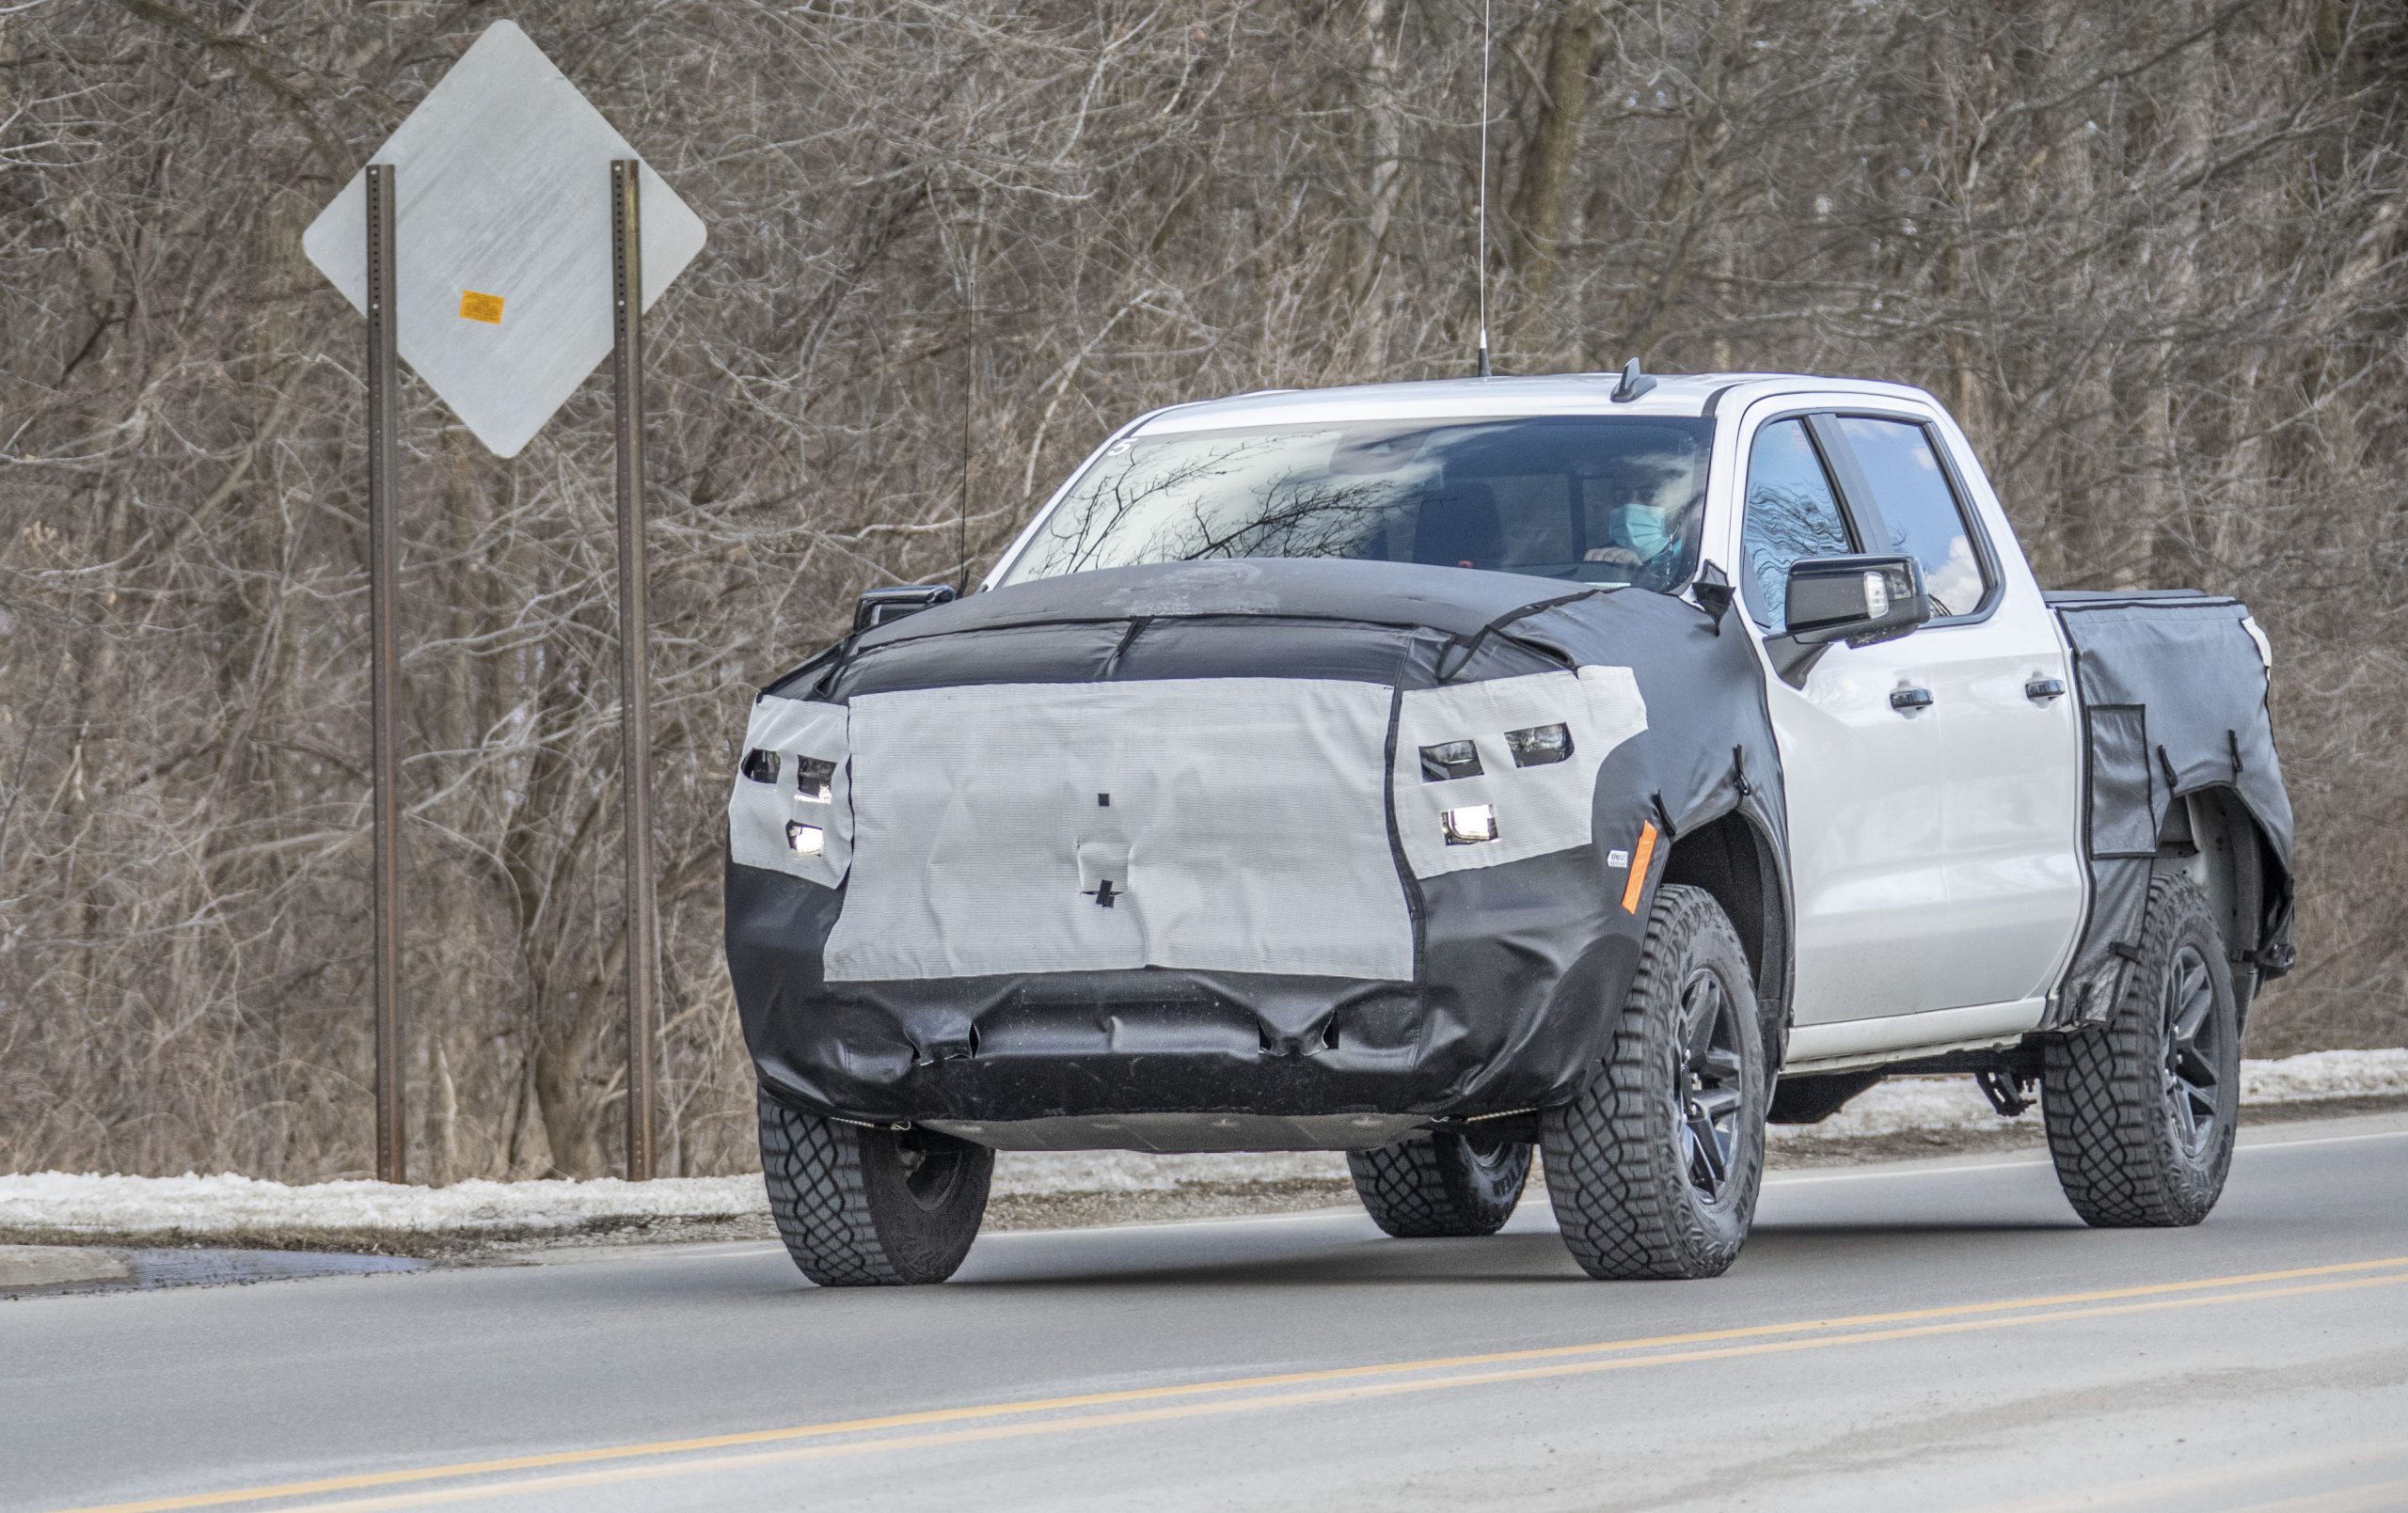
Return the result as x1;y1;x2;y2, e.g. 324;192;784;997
2039;875;2242;1229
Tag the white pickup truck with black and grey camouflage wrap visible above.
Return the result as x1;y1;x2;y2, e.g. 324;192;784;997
727;363;2292;1284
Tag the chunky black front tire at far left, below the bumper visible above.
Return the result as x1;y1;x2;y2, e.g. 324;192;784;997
761;1092;994;1287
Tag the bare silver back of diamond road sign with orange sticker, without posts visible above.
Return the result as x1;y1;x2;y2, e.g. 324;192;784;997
301;22;704;457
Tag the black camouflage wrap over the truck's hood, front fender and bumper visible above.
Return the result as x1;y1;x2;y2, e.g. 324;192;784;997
727;560;1789;1121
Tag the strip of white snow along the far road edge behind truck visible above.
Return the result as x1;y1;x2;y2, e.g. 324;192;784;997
0;1048;2408;1237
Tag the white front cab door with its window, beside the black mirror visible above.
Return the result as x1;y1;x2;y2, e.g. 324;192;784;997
1741;402;1956;1025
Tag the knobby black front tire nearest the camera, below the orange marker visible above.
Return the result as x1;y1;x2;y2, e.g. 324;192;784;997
1539;885;1767;1280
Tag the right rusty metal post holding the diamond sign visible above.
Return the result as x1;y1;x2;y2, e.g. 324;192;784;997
610;159;659;1181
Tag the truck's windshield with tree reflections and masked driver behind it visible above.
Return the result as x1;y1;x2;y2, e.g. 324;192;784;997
1002;417;1715;591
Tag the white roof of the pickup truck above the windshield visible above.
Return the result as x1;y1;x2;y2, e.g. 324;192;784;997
1132;372;1931;435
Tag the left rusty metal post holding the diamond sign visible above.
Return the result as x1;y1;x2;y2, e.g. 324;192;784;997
369;164;409;1181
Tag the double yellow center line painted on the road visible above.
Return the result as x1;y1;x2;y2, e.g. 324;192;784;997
52;1255;2408;1513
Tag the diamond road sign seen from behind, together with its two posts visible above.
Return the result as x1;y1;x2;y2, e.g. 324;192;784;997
301;22;704;1181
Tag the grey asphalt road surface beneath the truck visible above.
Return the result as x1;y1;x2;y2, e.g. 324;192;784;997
0;1116;2408;1513
